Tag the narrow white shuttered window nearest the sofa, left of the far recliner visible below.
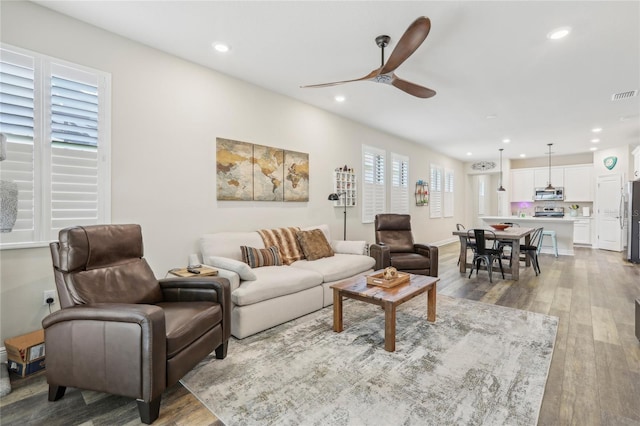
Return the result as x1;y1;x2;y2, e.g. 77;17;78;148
362;145;385;223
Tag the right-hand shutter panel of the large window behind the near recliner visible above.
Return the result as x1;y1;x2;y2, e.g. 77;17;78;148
51;66;99;234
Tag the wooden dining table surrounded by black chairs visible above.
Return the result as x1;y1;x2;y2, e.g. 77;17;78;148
453;226;535;281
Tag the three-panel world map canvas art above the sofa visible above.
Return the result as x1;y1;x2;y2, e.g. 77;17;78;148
216;138;309;201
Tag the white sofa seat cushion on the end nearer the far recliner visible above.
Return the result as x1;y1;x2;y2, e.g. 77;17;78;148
291;253;376;283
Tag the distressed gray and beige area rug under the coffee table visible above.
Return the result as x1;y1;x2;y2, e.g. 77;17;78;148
182;295;558;426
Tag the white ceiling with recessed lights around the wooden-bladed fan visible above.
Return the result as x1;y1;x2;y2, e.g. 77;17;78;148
36;1;640;161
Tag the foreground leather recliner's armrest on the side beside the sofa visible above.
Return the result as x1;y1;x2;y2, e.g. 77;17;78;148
159;277;231;341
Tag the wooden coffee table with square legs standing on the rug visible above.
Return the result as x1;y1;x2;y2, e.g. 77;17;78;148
331;271;440;352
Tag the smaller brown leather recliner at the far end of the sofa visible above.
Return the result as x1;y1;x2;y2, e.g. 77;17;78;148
369;213;438;277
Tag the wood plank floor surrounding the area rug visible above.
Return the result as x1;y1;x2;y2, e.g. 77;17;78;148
0;243;640;426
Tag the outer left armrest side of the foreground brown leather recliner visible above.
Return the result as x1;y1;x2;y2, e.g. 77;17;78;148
42;303;167;401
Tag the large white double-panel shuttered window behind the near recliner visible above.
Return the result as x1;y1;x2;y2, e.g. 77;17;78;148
0;44;111;249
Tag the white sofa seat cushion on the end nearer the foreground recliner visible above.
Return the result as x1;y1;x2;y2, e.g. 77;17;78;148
231;266;322;306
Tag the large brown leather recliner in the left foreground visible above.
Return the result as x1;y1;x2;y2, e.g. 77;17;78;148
42;225;231;424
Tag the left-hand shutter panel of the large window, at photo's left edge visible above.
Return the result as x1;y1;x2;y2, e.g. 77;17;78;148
0;49;36;243
